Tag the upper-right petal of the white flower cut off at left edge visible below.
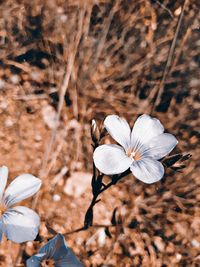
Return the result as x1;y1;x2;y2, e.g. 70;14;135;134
4;174;41;207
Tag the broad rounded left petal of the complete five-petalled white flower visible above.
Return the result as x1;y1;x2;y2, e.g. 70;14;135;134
93;145;132;175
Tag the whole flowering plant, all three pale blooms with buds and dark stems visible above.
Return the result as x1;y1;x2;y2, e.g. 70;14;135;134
0;114;190;267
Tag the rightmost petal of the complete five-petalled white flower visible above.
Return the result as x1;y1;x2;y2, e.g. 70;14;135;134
141;133;178;159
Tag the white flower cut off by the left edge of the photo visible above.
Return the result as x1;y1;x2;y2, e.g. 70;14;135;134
0;166;41;243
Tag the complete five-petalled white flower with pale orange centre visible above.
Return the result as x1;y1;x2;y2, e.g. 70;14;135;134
93;114;178;184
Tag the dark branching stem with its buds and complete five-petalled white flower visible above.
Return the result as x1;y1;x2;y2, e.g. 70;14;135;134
67;115;191;234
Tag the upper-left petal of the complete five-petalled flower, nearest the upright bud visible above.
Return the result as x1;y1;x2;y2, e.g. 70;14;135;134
104;115;131;149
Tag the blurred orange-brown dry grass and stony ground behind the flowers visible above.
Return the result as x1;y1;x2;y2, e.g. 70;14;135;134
0;0;200;267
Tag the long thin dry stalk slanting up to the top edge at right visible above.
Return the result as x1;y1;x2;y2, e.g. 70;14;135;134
151;0;188;113
